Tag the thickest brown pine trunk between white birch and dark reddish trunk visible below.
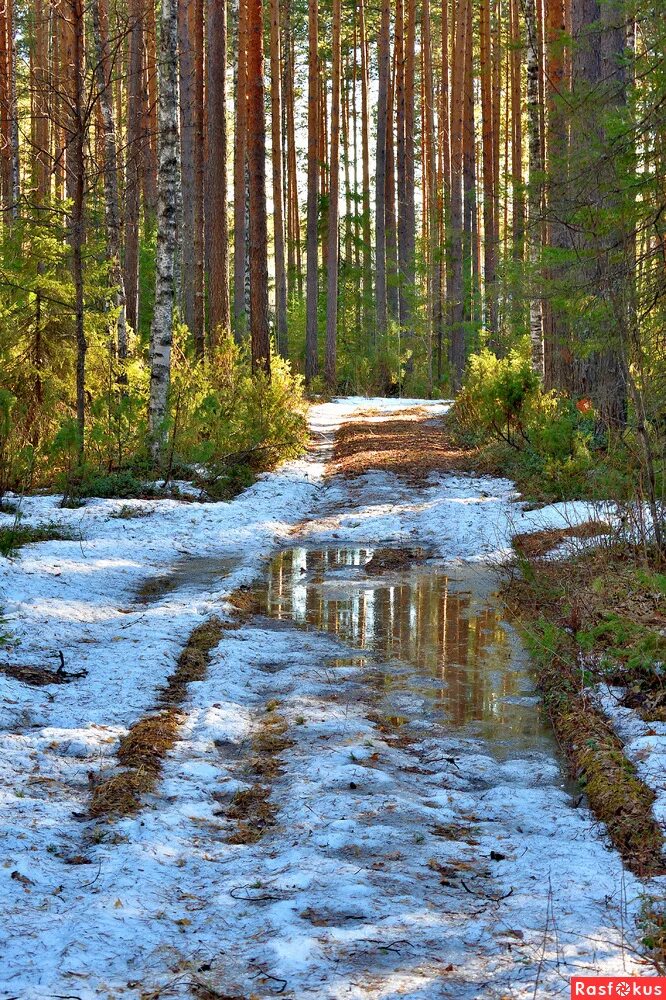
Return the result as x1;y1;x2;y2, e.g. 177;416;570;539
206;0;231;346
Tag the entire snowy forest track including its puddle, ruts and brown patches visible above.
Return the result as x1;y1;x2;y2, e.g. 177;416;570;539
0;399;664;1000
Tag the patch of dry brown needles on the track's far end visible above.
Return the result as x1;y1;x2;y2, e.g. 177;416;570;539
331;409;476;485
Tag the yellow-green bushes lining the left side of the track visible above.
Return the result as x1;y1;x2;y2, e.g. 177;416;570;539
0;336;307;507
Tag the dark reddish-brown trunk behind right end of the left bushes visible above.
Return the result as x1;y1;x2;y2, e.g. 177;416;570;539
247;0;271;377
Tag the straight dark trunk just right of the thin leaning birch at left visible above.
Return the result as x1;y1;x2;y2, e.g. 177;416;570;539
125;0;143;338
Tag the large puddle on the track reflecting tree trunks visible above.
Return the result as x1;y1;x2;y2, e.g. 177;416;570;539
256;547;554;757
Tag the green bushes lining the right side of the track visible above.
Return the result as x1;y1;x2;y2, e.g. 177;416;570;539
447;345;666;518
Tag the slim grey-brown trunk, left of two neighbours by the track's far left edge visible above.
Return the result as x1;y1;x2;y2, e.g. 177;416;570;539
305;0;319;382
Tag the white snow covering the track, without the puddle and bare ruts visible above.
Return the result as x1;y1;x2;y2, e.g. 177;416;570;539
0;398;660;1000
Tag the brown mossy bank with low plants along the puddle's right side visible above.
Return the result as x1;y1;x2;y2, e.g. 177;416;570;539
504;545;666;875
